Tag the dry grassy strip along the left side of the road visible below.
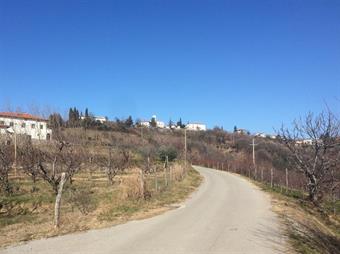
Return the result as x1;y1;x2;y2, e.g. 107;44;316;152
0;166;202;247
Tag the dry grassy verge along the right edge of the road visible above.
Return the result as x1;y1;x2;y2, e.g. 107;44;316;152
256;183;340;254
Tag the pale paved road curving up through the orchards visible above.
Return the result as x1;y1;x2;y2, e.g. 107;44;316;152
0;167;286;254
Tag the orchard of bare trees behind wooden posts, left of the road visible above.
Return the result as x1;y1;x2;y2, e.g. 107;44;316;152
0;120;191;233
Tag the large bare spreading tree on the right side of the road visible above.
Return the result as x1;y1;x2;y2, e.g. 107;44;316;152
278;110;340;204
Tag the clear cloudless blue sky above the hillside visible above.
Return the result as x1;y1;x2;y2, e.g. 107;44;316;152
0;0;340;132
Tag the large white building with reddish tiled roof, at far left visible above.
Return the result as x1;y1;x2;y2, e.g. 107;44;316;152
0;112;52;140
